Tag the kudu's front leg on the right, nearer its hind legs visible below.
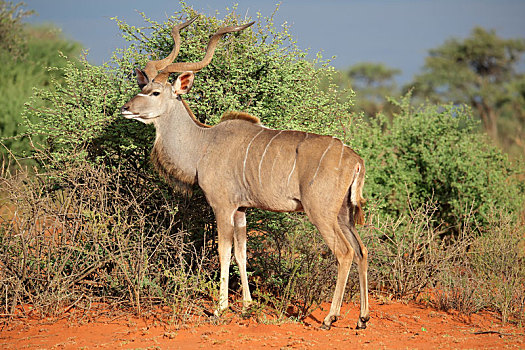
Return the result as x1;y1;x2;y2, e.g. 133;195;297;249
233;210;252;313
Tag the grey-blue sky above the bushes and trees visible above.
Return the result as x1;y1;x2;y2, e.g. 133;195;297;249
25;0;525;83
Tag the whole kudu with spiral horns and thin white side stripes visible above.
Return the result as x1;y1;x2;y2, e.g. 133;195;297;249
122;20;369;329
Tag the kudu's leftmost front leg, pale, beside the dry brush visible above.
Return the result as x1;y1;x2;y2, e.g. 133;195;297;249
215;210;233;316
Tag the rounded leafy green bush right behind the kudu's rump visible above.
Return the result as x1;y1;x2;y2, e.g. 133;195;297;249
349;95;525;232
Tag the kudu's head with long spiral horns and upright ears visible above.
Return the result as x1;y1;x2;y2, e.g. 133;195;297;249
121;17;255;124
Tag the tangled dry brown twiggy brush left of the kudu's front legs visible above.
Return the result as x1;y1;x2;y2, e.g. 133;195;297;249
0;160;213;322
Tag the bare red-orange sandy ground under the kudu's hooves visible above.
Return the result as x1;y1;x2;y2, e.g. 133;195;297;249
0;299;525;349
